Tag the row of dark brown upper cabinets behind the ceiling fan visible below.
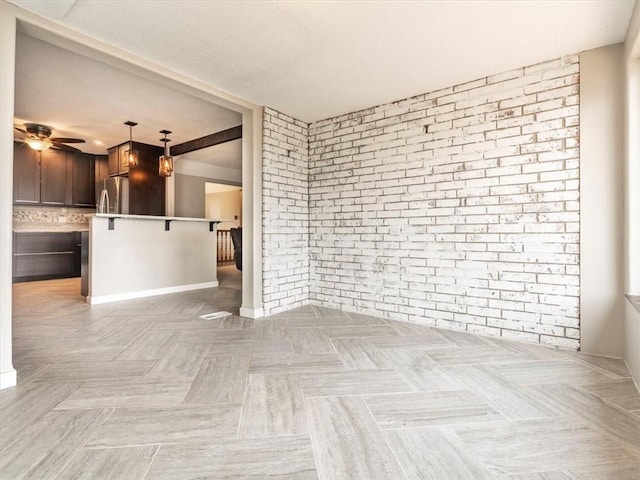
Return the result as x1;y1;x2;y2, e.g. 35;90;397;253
13;143;99;207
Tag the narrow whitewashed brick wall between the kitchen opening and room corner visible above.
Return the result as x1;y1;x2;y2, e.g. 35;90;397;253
262;108;309;315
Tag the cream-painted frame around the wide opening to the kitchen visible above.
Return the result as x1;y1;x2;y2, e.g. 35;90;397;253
0;6;262;389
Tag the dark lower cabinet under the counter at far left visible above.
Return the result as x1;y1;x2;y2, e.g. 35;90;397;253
13;232;81;283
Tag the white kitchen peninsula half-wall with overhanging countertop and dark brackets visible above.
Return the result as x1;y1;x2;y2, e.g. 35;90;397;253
83;214;219;304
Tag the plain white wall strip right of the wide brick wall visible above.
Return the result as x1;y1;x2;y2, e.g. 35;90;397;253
580;44;625;357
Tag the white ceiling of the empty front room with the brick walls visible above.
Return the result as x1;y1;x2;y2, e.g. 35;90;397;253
11;0;634;124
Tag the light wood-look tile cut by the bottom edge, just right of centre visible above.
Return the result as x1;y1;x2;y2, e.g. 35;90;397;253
305;397;406;480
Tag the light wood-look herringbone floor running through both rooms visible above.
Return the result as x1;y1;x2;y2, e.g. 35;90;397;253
0;270;640;480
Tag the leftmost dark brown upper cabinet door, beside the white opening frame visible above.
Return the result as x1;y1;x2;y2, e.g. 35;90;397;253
13;142;40;204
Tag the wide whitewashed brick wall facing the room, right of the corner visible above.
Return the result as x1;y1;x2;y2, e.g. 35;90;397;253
308;55;579;348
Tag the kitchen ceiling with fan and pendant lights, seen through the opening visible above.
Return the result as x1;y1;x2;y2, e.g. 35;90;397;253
15;34;242;161
